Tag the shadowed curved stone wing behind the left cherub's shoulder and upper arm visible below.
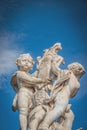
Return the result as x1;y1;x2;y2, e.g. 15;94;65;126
10;72;18;92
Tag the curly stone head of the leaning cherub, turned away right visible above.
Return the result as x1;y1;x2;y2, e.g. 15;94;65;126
68;62;85;78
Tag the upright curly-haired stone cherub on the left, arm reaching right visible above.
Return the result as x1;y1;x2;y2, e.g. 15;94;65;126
11;54;49;130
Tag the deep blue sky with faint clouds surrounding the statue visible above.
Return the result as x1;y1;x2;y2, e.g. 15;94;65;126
0;0;87;130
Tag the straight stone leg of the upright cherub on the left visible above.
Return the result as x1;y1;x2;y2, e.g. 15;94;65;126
18;92;31;130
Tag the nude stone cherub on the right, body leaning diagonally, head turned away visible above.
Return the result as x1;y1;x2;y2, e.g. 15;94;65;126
39;62;85;130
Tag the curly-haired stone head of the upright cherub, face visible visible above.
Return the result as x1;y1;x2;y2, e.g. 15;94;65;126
16;53;34;71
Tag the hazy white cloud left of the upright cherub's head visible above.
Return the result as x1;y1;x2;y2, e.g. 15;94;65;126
0;33;23;75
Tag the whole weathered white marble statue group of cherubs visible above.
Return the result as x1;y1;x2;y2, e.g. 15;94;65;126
11;43;85;130
